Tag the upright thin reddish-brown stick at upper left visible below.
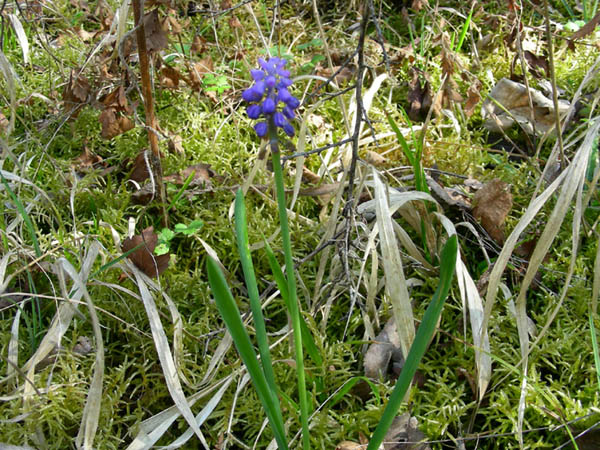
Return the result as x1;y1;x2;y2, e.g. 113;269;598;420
133;0;169;227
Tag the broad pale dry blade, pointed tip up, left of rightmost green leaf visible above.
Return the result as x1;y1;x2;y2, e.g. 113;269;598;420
373;169;415;357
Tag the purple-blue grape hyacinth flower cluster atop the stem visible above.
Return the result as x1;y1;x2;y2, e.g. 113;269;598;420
242;57;300;137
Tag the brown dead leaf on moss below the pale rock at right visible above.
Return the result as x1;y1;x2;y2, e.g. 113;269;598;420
473;178;512;244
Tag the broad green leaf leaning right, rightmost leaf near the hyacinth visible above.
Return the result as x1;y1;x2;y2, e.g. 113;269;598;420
367;235;458;450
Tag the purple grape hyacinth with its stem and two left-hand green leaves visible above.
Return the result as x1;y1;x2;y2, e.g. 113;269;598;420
207;57;310;450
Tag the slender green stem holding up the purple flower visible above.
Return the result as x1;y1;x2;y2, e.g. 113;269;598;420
269;118;310;450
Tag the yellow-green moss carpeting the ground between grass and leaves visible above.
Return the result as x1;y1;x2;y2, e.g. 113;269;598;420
0;2;600;449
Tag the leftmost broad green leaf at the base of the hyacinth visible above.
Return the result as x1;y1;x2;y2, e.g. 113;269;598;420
206;256;288;449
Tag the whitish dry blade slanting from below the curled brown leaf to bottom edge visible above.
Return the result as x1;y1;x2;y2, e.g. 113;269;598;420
127;263;209;450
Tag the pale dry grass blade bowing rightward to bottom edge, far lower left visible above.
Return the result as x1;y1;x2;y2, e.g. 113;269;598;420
58;258;104;450
